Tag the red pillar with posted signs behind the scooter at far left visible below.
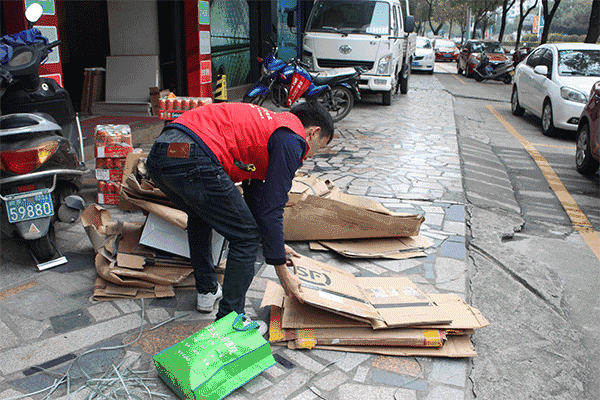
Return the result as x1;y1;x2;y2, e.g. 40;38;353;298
3;0;62;86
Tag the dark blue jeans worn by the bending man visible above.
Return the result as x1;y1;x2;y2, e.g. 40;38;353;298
146;129;260;319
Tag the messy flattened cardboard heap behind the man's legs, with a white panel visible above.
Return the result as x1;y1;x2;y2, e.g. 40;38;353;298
81;152;225;300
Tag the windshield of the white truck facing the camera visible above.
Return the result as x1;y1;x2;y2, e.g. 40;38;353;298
306;0;390;35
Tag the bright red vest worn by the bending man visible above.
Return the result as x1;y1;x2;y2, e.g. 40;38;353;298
173;103;308;182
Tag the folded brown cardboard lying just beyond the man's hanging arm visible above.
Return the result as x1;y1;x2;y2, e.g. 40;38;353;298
283;174;433;260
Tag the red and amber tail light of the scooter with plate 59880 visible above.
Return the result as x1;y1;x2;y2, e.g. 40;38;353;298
0;141;58;174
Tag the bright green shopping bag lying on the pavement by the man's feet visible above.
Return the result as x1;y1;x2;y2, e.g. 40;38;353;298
153;312;275;400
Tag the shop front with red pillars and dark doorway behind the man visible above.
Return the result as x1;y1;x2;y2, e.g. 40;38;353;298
1;0;312;109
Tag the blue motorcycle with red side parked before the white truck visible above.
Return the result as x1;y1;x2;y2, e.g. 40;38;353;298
242;40;364;122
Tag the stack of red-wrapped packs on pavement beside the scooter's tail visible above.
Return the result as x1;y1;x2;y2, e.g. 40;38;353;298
95;125;133;204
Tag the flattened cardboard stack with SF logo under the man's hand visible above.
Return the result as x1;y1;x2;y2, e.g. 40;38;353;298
261;257;489;357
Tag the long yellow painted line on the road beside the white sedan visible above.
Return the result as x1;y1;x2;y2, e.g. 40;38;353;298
486;104;600;260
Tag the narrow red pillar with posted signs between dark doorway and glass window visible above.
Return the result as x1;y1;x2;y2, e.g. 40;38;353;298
184;0;212;97
